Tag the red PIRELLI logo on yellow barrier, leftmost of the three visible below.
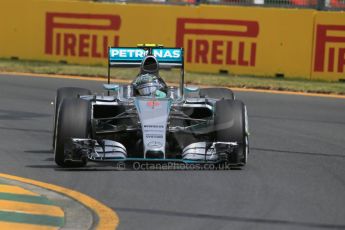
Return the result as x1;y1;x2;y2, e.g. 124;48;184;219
45;12;121;58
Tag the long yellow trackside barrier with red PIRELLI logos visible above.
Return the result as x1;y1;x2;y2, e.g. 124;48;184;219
0;0;345;80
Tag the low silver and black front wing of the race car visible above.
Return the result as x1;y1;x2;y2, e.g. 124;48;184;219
65;138;238;163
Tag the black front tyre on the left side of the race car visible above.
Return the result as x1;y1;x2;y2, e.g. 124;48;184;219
54;98;91;167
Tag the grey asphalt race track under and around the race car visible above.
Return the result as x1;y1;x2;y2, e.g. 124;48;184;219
0;75;345;230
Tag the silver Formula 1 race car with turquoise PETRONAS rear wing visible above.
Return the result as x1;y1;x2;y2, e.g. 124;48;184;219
53;45;249;167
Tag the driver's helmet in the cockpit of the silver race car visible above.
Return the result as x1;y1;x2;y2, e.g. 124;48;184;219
133;73;166;96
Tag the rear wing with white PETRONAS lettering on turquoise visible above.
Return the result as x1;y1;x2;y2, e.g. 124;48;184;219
108;44;184;95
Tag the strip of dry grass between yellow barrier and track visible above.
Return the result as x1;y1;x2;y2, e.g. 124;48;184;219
0;59;345;95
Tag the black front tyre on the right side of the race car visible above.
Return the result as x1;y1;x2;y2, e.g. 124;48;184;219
214;100;249;166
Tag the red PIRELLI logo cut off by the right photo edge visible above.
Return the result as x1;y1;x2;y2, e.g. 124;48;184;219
314;24;345;73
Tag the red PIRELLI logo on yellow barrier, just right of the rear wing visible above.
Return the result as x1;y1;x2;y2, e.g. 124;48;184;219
176;18;259;67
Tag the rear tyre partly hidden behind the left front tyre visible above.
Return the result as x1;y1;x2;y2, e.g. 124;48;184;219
52;87;91;148
